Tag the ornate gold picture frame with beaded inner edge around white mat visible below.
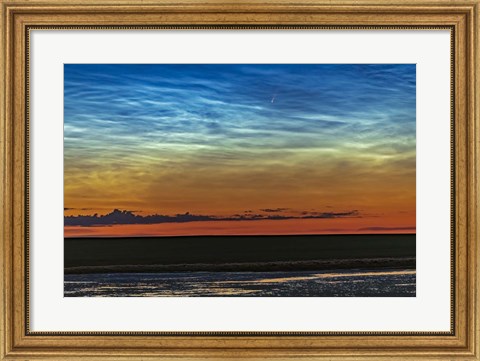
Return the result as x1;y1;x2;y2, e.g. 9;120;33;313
0;0;480;360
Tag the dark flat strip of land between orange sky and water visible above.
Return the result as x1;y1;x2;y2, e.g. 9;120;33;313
64;234;416;273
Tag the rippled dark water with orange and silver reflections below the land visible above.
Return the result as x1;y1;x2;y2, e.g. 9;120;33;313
64;270;416;297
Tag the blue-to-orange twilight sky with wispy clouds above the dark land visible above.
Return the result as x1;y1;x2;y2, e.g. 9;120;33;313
64;64;416;237
